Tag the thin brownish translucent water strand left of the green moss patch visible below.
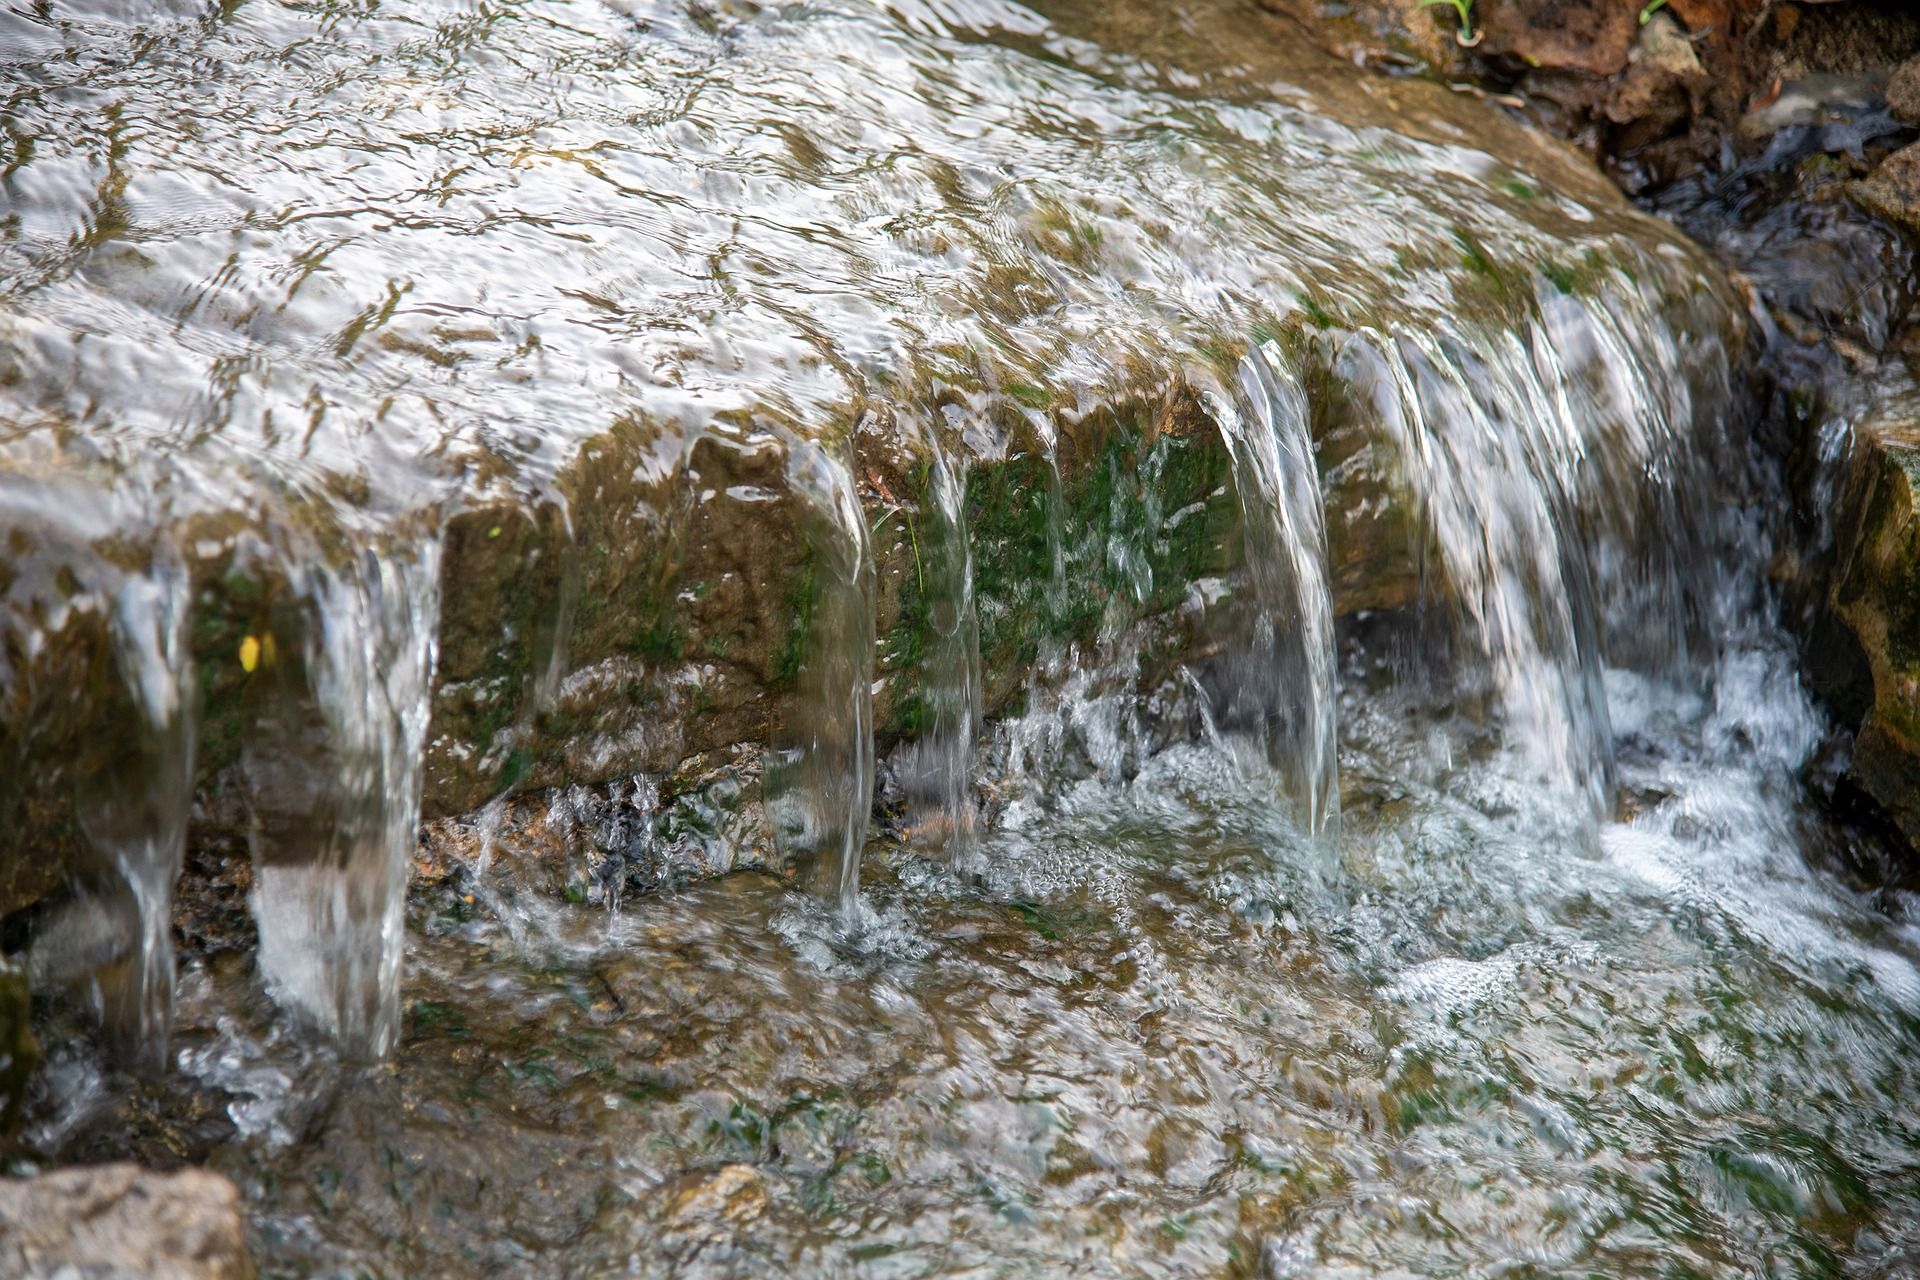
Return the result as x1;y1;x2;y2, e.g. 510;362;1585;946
766;441;874;921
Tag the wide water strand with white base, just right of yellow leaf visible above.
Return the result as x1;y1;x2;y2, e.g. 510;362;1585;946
253;537;440;1055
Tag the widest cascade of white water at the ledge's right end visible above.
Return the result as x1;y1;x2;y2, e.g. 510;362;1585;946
1332;282;1726;819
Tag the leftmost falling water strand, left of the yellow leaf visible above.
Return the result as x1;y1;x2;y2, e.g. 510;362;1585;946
79;560;194;1063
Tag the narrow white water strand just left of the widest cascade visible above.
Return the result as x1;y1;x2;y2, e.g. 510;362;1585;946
1213;344;1340;841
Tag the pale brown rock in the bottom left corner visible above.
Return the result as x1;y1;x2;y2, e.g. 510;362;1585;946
0;1165;253;1280
